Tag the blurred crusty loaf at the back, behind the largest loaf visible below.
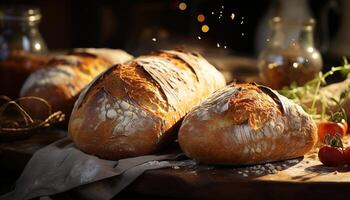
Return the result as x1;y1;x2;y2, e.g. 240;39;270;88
20;49;132;118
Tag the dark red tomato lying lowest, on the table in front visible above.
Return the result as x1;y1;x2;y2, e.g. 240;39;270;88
318;146;345;167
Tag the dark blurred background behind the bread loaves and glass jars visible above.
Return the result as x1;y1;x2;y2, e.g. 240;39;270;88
0;0;350;85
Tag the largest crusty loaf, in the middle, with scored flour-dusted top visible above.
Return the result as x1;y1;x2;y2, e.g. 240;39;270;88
68;50;225;160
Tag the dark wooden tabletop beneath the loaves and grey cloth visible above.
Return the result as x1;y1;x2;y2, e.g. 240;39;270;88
0;131;350;199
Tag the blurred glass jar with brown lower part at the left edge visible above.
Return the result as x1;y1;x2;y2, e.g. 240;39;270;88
0;7;48;98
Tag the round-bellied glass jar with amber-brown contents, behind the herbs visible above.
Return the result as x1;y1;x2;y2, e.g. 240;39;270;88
258;17;322;89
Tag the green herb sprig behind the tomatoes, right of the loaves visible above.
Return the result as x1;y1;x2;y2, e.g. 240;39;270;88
279;58;350;120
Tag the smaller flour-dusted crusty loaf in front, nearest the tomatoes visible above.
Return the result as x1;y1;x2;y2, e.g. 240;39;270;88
178;84;317;165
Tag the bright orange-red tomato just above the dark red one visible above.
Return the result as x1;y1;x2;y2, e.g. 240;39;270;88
317;120;348;142
